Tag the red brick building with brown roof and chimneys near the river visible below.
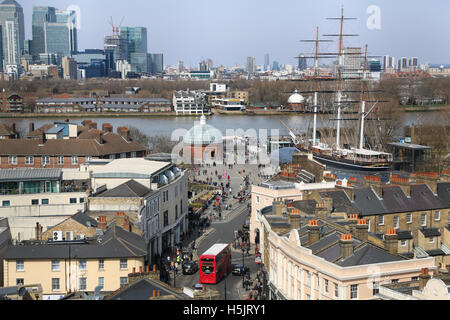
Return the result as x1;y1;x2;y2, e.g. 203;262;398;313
0;120;147;169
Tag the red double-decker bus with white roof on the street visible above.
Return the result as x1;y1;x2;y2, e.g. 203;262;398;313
199;243;231;284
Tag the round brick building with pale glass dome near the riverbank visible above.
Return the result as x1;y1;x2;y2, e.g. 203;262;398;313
183;115;223;164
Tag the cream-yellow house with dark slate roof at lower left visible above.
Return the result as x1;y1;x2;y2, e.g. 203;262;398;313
3;225;147;300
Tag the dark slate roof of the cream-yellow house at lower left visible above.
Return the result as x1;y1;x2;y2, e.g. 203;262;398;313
3;224;147;260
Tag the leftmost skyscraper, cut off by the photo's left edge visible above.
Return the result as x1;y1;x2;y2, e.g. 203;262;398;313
0;0;25;66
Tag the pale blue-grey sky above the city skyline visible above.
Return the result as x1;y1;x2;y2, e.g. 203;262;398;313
17;0;450;67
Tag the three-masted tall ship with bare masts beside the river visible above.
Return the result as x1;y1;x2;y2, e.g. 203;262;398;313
281;7;393;171
